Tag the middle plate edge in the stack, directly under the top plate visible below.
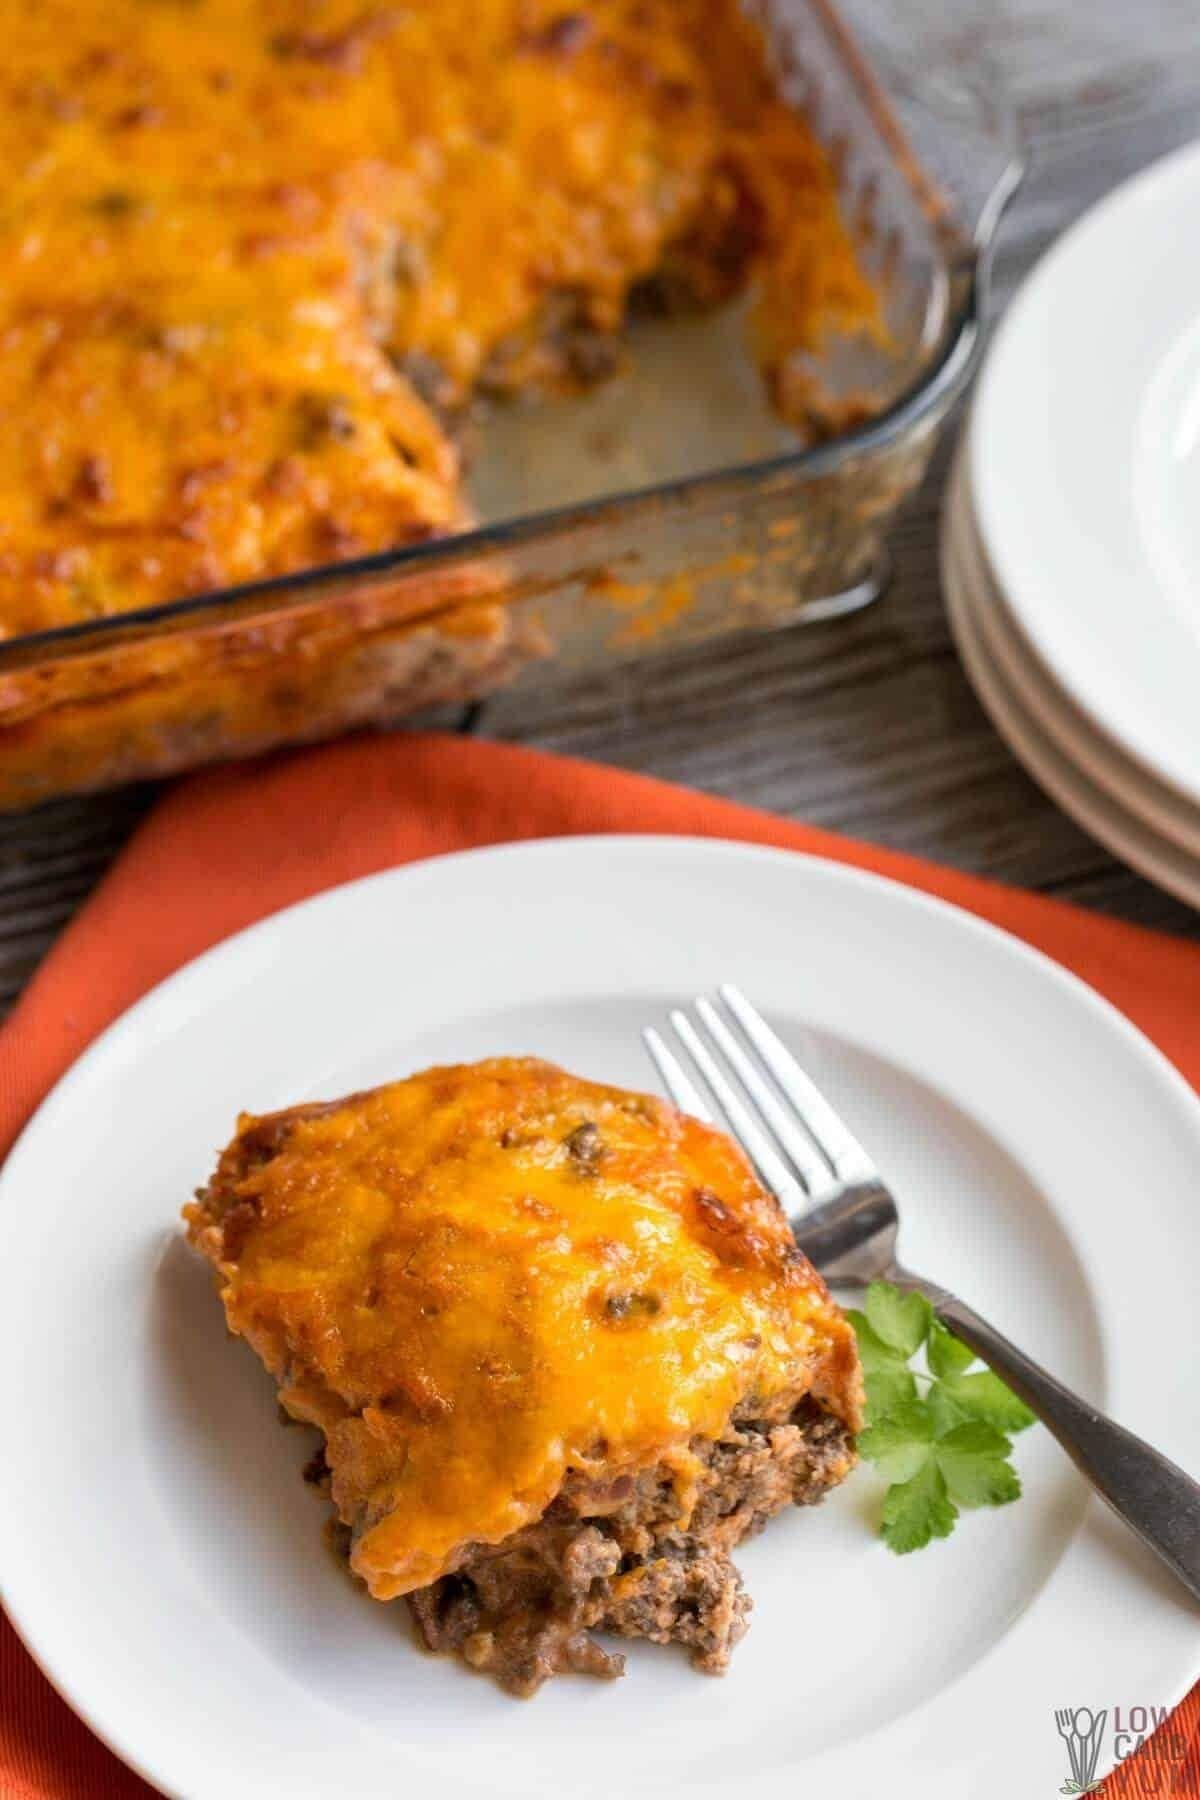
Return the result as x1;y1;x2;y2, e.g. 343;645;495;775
943;454;1200;859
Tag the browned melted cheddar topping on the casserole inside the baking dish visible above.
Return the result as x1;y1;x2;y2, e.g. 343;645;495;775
0;0;873;635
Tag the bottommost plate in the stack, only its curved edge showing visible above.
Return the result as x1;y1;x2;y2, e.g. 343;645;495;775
941;468;1200;907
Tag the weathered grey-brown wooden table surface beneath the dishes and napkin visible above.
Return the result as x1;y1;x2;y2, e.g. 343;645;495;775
0;0;1200;1006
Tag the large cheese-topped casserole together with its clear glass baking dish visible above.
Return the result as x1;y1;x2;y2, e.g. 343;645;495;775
0;0;1007;805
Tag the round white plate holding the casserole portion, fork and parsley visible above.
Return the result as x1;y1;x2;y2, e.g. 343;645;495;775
0;837;1200;1800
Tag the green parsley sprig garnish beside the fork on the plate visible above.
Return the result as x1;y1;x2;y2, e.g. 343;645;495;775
846;1282;1034;1555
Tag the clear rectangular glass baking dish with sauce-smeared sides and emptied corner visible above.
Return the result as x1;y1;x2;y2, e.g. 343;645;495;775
0;0;1018;808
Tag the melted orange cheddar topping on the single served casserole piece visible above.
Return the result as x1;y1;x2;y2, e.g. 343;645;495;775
187;1058;862;1598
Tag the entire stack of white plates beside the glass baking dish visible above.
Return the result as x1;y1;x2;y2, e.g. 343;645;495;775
941;146;1200;907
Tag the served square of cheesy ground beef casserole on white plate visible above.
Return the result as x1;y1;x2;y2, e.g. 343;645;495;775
185;1058;864;1694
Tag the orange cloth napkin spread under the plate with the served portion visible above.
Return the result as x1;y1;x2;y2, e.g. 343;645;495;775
0;736;1200;1800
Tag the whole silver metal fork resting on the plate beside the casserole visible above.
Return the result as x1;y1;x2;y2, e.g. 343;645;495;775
642;985;1200;1600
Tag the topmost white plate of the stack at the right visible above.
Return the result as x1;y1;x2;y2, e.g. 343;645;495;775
966;146;1200;805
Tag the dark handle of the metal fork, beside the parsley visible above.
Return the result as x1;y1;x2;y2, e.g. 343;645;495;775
928;1289;1200;1600
